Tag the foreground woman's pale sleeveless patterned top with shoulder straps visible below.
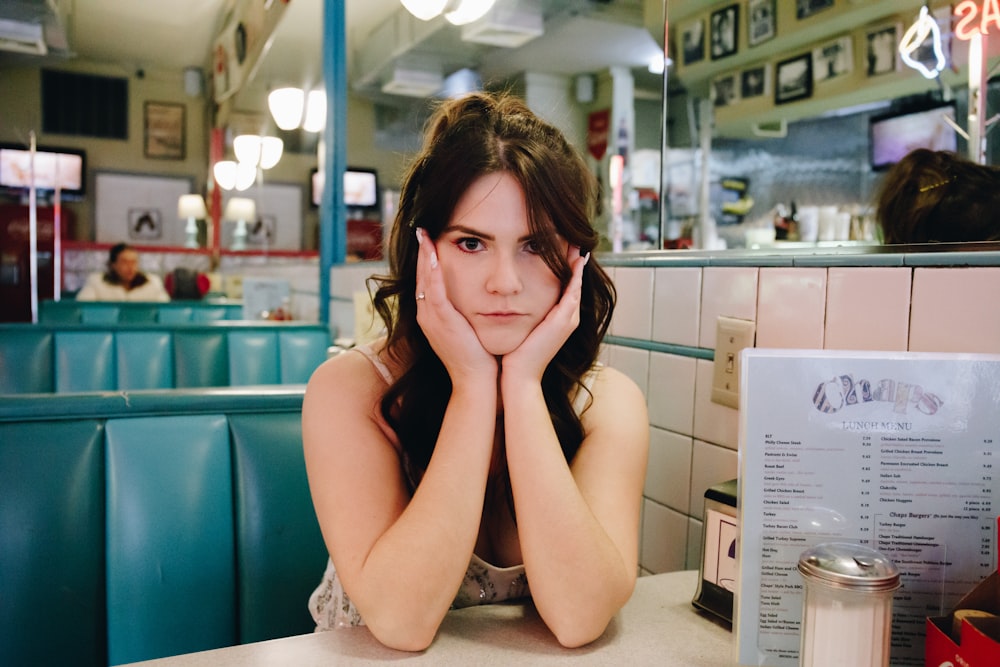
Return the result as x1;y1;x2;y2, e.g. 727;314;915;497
309;345;600;632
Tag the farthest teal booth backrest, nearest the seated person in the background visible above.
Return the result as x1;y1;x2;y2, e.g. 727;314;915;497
38;299;243;324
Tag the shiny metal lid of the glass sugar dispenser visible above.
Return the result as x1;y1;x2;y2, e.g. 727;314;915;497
799;542;899;592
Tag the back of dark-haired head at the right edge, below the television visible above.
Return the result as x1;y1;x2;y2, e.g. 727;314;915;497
875;148;1000;243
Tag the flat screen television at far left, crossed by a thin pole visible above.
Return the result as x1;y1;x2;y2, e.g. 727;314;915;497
0;144;87;200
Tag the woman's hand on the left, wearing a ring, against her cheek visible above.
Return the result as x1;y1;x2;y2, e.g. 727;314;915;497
416;227;497;384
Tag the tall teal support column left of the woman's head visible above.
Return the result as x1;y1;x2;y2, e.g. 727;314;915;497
319;0;347;324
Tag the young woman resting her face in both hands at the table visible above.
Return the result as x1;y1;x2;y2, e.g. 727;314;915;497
302;94;649;650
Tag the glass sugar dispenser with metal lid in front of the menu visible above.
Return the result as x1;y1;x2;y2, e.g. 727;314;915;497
798;542;900;667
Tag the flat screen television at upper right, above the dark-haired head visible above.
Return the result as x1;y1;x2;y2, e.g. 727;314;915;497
868;103;958;171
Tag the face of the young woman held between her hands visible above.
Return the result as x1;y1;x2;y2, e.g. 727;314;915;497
436;172;568;356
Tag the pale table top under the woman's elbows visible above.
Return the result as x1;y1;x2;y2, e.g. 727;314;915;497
127;570;734;667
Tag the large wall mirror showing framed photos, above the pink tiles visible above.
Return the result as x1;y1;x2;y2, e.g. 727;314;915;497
660;0;1000;250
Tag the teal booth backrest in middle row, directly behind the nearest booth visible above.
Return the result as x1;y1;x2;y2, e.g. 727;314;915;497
0;321;330;394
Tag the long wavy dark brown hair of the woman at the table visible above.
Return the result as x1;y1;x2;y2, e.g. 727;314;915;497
372;93;615;479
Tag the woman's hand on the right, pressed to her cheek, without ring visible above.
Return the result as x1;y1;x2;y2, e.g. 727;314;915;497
502;246;590;381
